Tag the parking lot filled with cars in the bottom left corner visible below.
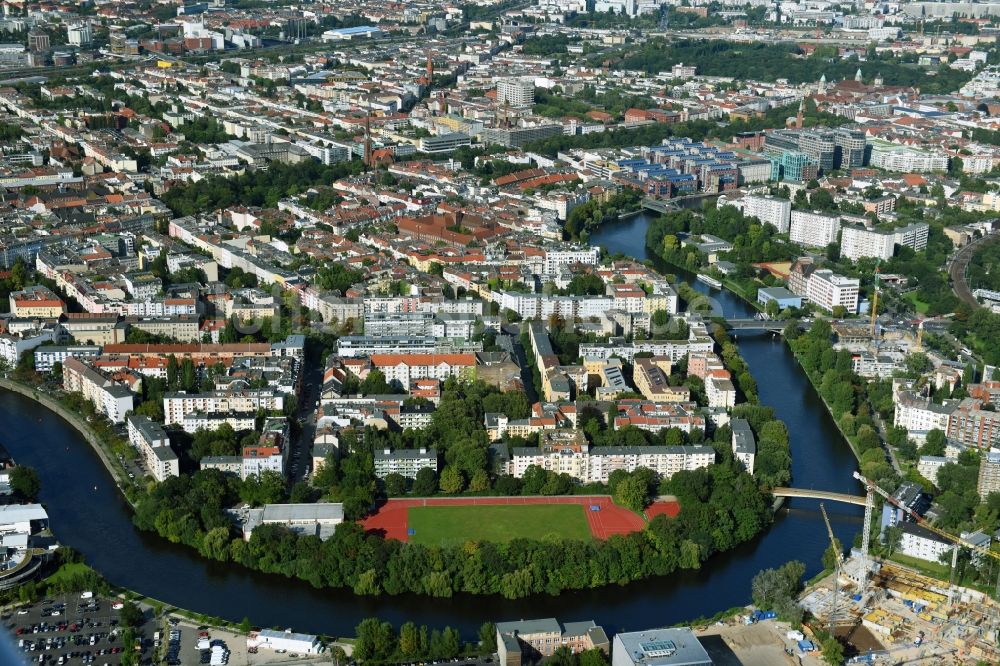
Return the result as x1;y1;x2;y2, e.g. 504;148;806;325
2;594;150;666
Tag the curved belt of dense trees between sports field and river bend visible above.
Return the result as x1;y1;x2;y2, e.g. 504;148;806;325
133;460;770;599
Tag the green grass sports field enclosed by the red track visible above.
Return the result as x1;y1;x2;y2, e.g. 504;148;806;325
409;504;592;546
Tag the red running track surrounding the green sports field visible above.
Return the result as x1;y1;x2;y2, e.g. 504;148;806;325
361;495;680;541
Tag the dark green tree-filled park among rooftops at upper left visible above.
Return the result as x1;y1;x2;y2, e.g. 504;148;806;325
160;160;363;216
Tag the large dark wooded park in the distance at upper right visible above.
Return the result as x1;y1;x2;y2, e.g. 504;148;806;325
618;39;972;94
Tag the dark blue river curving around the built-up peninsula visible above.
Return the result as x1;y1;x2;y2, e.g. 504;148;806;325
0;215;861;639
